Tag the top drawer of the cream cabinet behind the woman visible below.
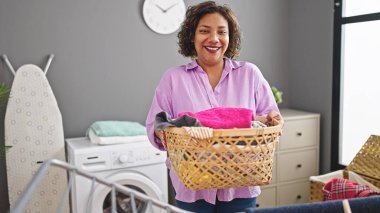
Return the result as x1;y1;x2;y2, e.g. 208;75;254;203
279;118;319;150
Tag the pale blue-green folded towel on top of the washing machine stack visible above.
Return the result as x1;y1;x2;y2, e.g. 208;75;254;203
89;121;146;137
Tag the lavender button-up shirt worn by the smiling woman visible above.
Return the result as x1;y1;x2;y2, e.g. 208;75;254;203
146;58;279;204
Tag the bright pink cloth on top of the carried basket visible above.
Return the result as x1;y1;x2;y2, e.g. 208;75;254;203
178;107;254;129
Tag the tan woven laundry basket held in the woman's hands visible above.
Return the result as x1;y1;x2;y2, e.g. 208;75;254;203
164;124;282;190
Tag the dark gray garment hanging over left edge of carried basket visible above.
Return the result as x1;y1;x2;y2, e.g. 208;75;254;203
154;112;203;131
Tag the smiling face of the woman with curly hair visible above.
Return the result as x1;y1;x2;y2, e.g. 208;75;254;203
194;13;229;67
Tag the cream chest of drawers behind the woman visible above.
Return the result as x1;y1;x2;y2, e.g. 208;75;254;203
256;109;320;208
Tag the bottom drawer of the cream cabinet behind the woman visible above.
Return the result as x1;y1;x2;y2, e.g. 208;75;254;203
277;181;310;206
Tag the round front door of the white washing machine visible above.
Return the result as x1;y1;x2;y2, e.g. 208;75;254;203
87;171;165;213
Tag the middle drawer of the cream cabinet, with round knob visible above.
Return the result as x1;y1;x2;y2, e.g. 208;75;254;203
277;149;318;182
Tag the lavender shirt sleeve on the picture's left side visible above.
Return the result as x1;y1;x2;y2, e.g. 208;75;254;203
145;72;173;150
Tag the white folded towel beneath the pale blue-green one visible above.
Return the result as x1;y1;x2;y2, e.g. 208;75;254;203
88;129;149;145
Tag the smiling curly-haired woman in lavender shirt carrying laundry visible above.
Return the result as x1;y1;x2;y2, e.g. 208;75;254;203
146;1;282;213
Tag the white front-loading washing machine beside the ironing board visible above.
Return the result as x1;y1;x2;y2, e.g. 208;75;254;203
66;138;168;213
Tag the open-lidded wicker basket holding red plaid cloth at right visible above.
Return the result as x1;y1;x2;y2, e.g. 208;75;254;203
309;135;380;202
